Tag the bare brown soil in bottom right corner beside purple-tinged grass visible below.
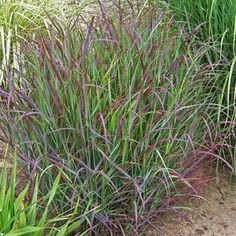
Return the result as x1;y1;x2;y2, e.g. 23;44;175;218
146;173;236;236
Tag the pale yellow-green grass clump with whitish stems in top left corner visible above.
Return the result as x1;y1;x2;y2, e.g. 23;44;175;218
0;0;52;83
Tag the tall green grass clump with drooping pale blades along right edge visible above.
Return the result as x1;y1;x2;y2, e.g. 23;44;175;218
169;0;236;169
